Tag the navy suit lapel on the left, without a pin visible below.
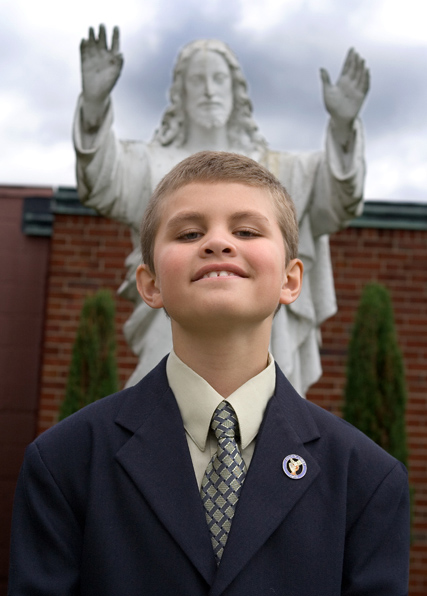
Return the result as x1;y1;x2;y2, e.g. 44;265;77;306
116;363;216;584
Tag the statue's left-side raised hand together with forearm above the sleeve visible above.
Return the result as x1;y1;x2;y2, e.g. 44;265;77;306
80;25;123;148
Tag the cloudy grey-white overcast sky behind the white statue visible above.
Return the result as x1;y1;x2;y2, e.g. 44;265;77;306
0;0;427;202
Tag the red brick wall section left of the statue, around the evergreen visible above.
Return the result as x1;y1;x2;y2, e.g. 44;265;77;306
38;215;137;432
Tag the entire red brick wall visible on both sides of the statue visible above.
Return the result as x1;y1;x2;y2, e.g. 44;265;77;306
34;210;427;595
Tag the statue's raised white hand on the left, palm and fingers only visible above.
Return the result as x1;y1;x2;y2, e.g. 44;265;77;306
80;25;123;105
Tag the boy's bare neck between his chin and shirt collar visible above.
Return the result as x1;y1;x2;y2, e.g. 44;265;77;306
173;328;270;398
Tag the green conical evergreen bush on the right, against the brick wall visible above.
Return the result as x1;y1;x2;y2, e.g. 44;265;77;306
343;283;408;466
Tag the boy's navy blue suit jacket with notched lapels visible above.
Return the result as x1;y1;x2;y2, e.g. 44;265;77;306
9;361;409;596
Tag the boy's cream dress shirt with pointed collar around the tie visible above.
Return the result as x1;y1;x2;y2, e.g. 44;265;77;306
166;351;276;488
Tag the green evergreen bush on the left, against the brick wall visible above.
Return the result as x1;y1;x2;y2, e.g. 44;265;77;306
59;290;118;420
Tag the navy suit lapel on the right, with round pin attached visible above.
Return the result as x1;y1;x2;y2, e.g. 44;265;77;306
210;370;320;596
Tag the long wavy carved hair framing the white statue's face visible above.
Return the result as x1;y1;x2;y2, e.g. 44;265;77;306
152;39;267;151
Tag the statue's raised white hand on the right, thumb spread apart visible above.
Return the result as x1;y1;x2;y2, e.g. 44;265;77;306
320;48;369;126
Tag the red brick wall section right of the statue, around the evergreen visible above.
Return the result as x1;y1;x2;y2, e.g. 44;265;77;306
308;228;427;596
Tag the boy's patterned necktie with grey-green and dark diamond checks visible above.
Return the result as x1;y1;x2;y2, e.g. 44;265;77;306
200;401;246;565
